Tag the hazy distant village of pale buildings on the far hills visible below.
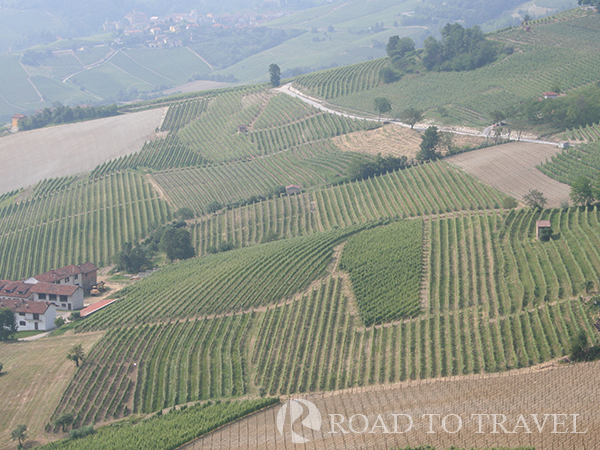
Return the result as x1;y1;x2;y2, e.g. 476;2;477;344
103;7;286;48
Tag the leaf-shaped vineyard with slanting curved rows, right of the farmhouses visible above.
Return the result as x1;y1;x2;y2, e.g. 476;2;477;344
72;225;365;331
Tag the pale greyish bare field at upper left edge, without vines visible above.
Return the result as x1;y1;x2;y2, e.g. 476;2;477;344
0;108;167;194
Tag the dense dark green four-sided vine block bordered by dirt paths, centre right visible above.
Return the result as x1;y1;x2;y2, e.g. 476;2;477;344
340;220;423;326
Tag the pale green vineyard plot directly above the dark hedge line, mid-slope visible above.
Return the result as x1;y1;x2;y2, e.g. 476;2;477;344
153;141;368;215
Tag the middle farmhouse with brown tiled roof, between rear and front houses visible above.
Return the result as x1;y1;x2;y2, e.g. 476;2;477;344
0;278;83;311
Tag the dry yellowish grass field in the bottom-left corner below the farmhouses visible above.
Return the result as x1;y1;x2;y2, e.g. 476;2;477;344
0;332;104;449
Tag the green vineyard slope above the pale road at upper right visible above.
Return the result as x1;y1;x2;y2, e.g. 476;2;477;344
295;12;600;125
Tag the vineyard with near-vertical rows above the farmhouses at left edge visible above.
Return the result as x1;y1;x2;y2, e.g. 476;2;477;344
0;173;171;280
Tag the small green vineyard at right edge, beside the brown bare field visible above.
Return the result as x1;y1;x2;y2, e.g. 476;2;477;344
538;143;600;184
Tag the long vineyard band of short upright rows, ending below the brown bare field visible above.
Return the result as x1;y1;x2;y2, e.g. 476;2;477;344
188;162;504;254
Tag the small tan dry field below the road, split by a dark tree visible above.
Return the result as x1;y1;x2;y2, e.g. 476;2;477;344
333;124;485;159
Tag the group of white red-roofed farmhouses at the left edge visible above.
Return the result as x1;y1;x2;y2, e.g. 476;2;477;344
0;262;98;331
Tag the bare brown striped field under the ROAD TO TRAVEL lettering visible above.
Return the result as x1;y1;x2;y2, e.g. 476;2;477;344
183;362;600;450
